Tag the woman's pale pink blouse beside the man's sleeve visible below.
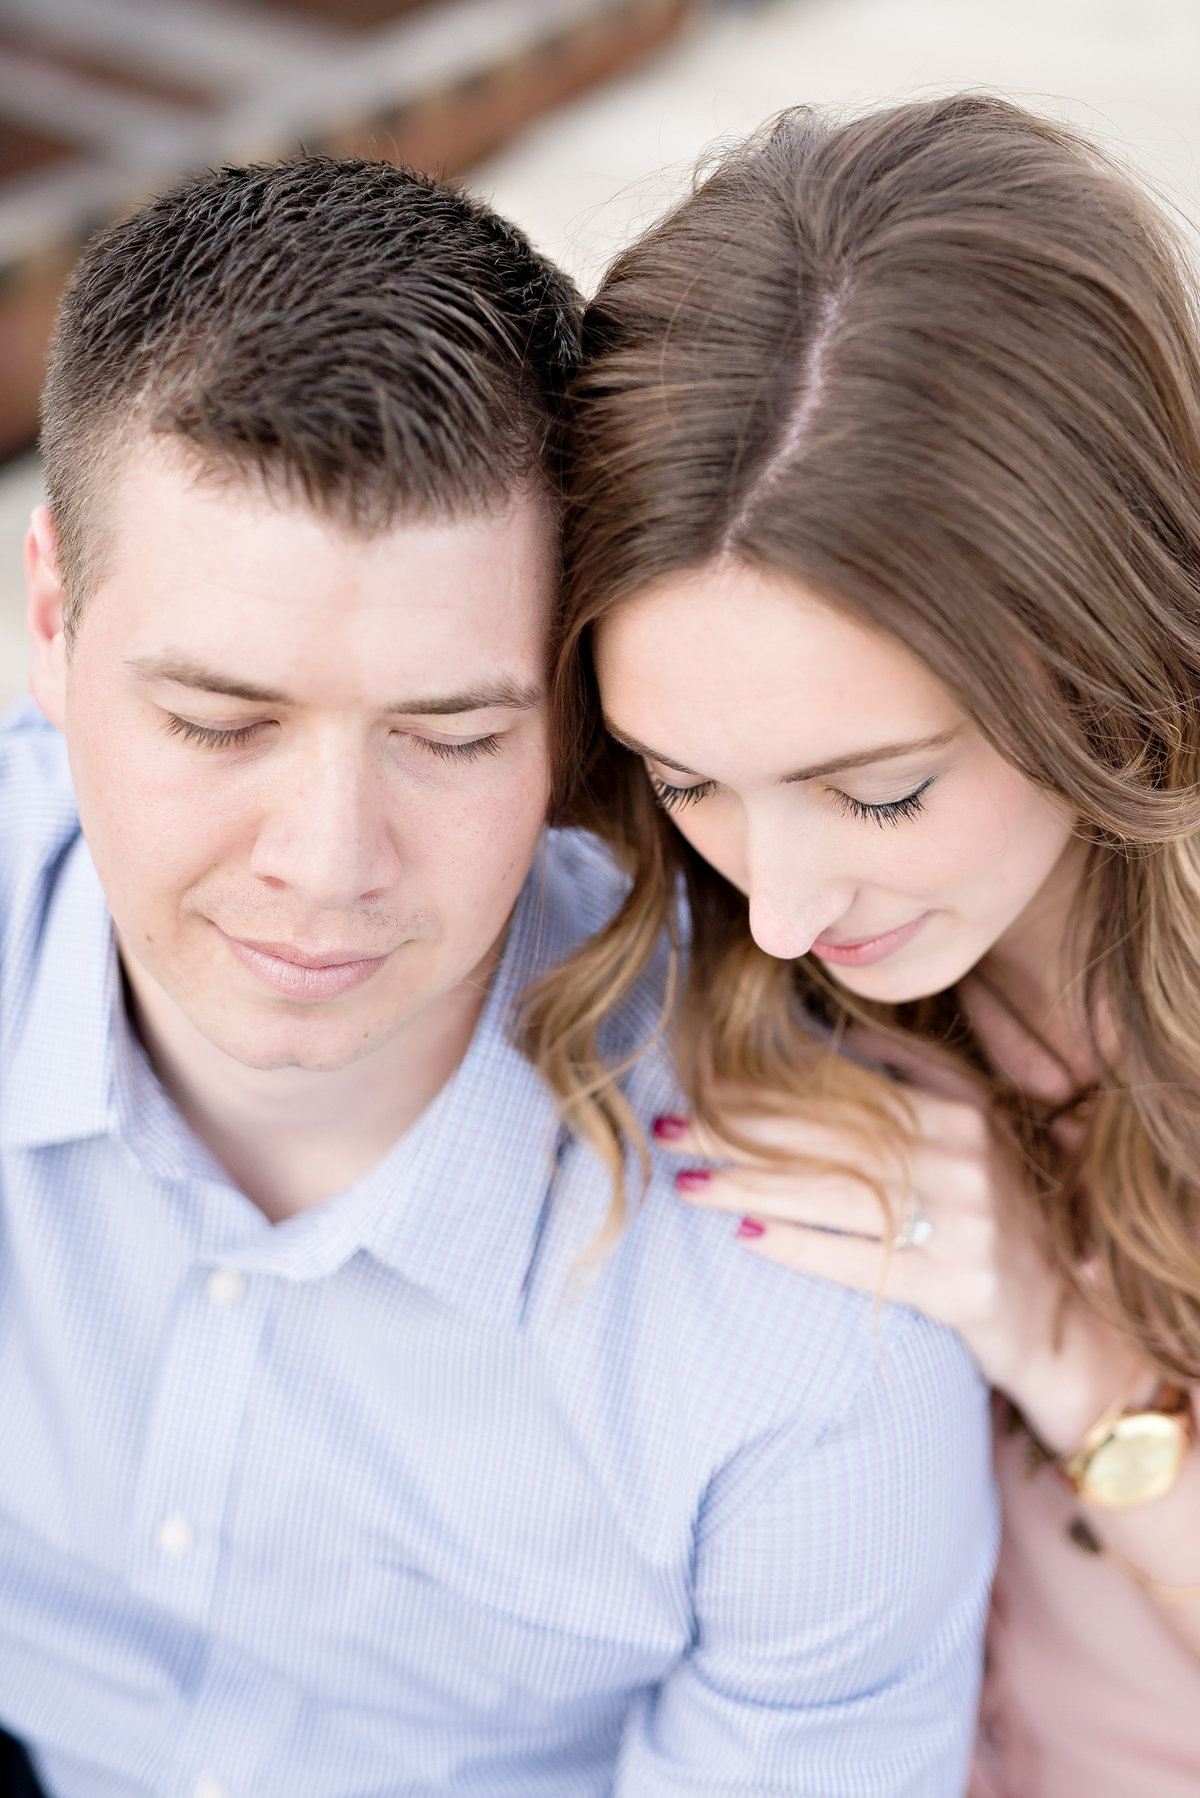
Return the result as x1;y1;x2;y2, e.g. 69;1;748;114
970;1435;1200;1798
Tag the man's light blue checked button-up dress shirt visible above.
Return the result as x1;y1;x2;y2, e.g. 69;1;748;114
0;710;995;1798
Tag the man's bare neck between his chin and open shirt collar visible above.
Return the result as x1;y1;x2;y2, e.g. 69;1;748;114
122;955;497;1223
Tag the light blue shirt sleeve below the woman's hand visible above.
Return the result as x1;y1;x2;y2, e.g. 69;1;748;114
615;1305;997;1798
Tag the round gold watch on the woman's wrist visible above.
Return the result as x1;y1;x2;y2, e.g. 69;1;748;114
1060;1379;1195;1510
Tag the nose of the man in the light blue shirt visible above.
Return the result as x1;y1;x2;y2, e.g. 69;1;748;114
250;741;399;912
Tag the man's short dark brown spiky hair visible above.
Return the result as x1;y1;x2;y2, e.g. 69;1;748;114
41;156;578;629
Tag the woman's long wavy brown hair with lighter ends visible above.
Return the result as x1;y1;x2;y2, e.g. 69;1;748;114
525;95;1200;1381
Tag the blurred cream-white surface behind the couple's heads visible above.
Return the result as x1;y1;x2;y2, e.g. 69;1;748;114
0;0;1200;705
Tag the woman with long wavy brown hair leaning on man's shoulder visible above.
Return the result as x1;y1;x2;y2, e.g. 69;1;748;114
531;97;1200;1798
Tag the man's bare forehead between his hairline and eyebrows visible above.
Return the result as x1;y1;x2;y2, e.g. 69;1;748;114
82;442;558;668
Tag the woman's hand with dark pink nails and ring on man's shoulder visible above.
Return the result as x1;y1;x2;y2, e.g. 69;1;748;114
655;1050;1155;1453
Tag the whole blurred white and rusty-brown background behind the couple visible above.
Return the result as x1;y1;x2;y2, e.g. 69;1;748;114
0;0;1200;707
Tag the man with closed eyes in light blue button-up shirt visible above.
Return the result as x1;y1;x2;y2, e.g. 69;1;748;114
0;158;991;1798
